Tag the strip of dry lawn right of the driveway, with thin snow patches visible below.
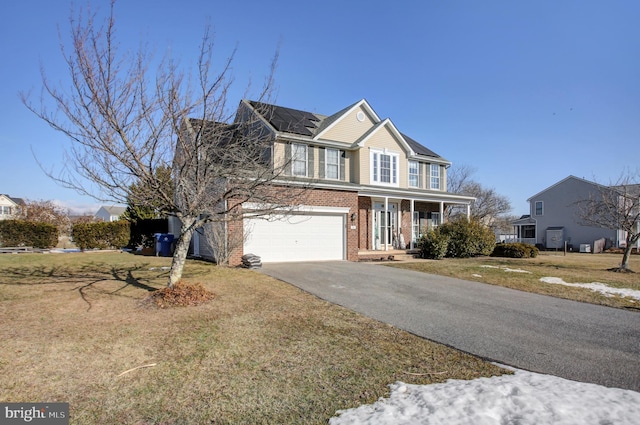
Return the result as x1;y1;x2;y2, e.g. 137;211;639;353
391;251;640;310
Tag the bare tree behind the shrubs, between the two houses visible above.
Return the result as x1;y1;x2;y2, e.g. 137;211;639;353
445;164;511;226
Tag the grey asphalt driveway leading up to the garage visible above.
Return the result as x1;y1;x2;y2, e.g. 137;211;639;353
262;261;640;391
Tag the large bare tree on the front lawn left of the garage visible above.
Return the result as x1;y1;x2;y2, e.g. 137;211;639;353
22;1;301;287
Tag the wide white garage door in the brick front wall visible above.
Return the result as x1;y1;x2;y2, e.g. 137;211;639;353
244;214;345;262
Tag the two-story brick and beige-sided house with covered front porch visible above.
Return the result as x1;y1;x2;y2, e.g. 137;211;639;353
180;100;474;265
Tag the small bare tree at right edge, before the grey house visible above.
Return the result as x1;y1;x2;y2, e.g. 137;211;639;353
576;173;640;272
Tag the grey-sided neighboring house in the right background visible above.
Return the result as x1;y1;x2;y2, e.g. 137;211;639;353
512;176;624;252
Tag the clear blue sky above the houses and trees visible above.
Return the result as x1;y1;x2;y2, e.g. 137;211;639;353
0;0;640;215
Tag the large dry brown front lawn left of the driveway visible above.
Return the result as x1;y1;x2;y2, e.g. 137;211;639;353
0;253;505;425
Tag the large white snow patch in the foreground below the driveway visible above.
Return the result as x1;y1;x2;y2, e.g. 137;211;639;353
329;370;640;425
